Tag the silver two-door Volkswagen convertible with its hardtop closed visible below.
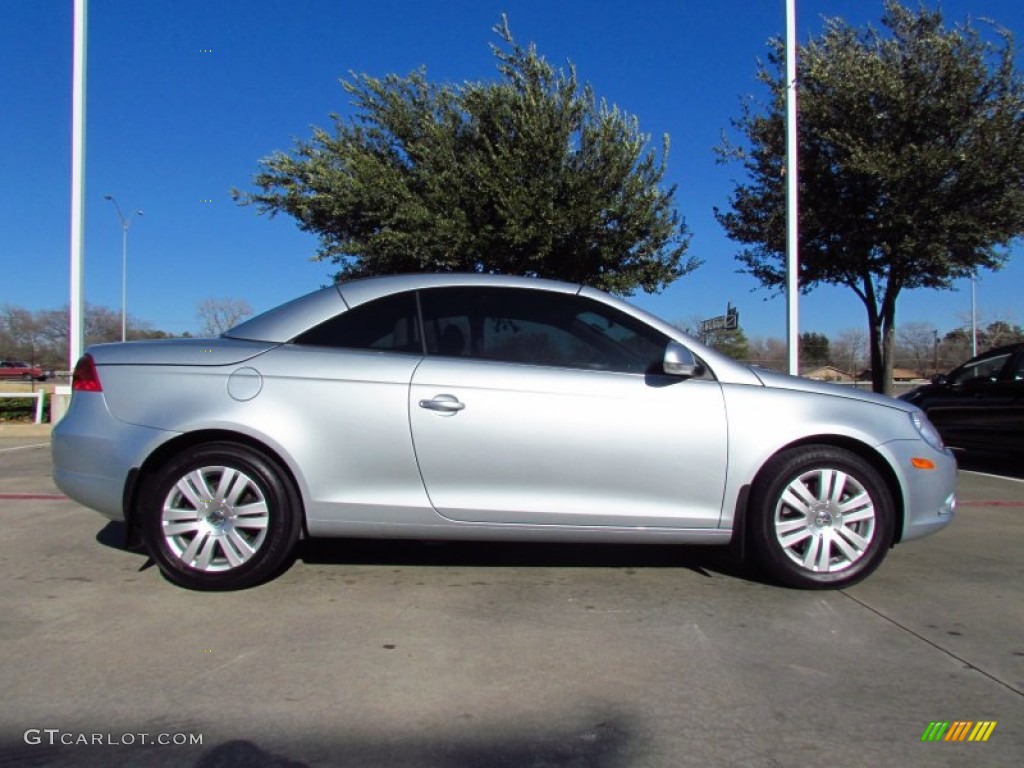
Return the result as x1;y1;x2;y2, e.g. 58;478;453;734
52;274;956;589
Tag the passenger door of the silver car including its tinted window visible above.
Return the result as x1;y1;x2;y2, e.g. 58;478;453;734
410;288;726;527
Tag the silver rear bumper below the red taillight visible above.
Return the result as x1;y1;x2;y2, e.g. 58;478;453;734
50;392;176;520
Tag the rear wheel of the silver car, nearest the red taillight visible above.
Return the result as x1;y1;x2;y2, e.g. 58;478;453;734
137;442;300;590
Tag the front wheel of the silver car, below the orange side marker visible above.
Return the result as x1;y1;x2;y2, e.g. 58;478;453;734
748;445;895;589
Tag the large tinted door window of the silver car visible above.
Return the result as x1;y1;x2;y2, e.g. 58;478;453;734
421;288;668;374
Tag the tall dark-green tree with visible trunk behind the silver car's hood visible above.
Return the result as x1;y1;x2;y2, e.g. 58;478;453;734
716;0;1024;391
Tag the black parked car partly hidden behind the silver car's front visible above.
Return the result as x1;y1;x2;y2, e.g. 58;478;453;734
902;344;1024;458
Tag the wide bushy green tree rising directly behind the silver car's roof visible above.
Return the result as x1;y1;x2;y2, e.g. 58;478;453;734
234;17;698;294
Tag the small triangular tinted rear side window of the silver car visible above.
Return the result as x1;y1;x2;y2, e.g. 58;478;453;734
293;291;423;354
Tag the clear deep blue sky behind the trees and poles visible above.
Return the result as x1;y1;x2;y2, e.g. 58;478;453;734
0;0;1024;338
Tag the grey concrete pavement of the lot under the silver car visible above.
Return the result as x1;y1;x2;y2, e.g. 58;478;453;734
0;435;1024;768
